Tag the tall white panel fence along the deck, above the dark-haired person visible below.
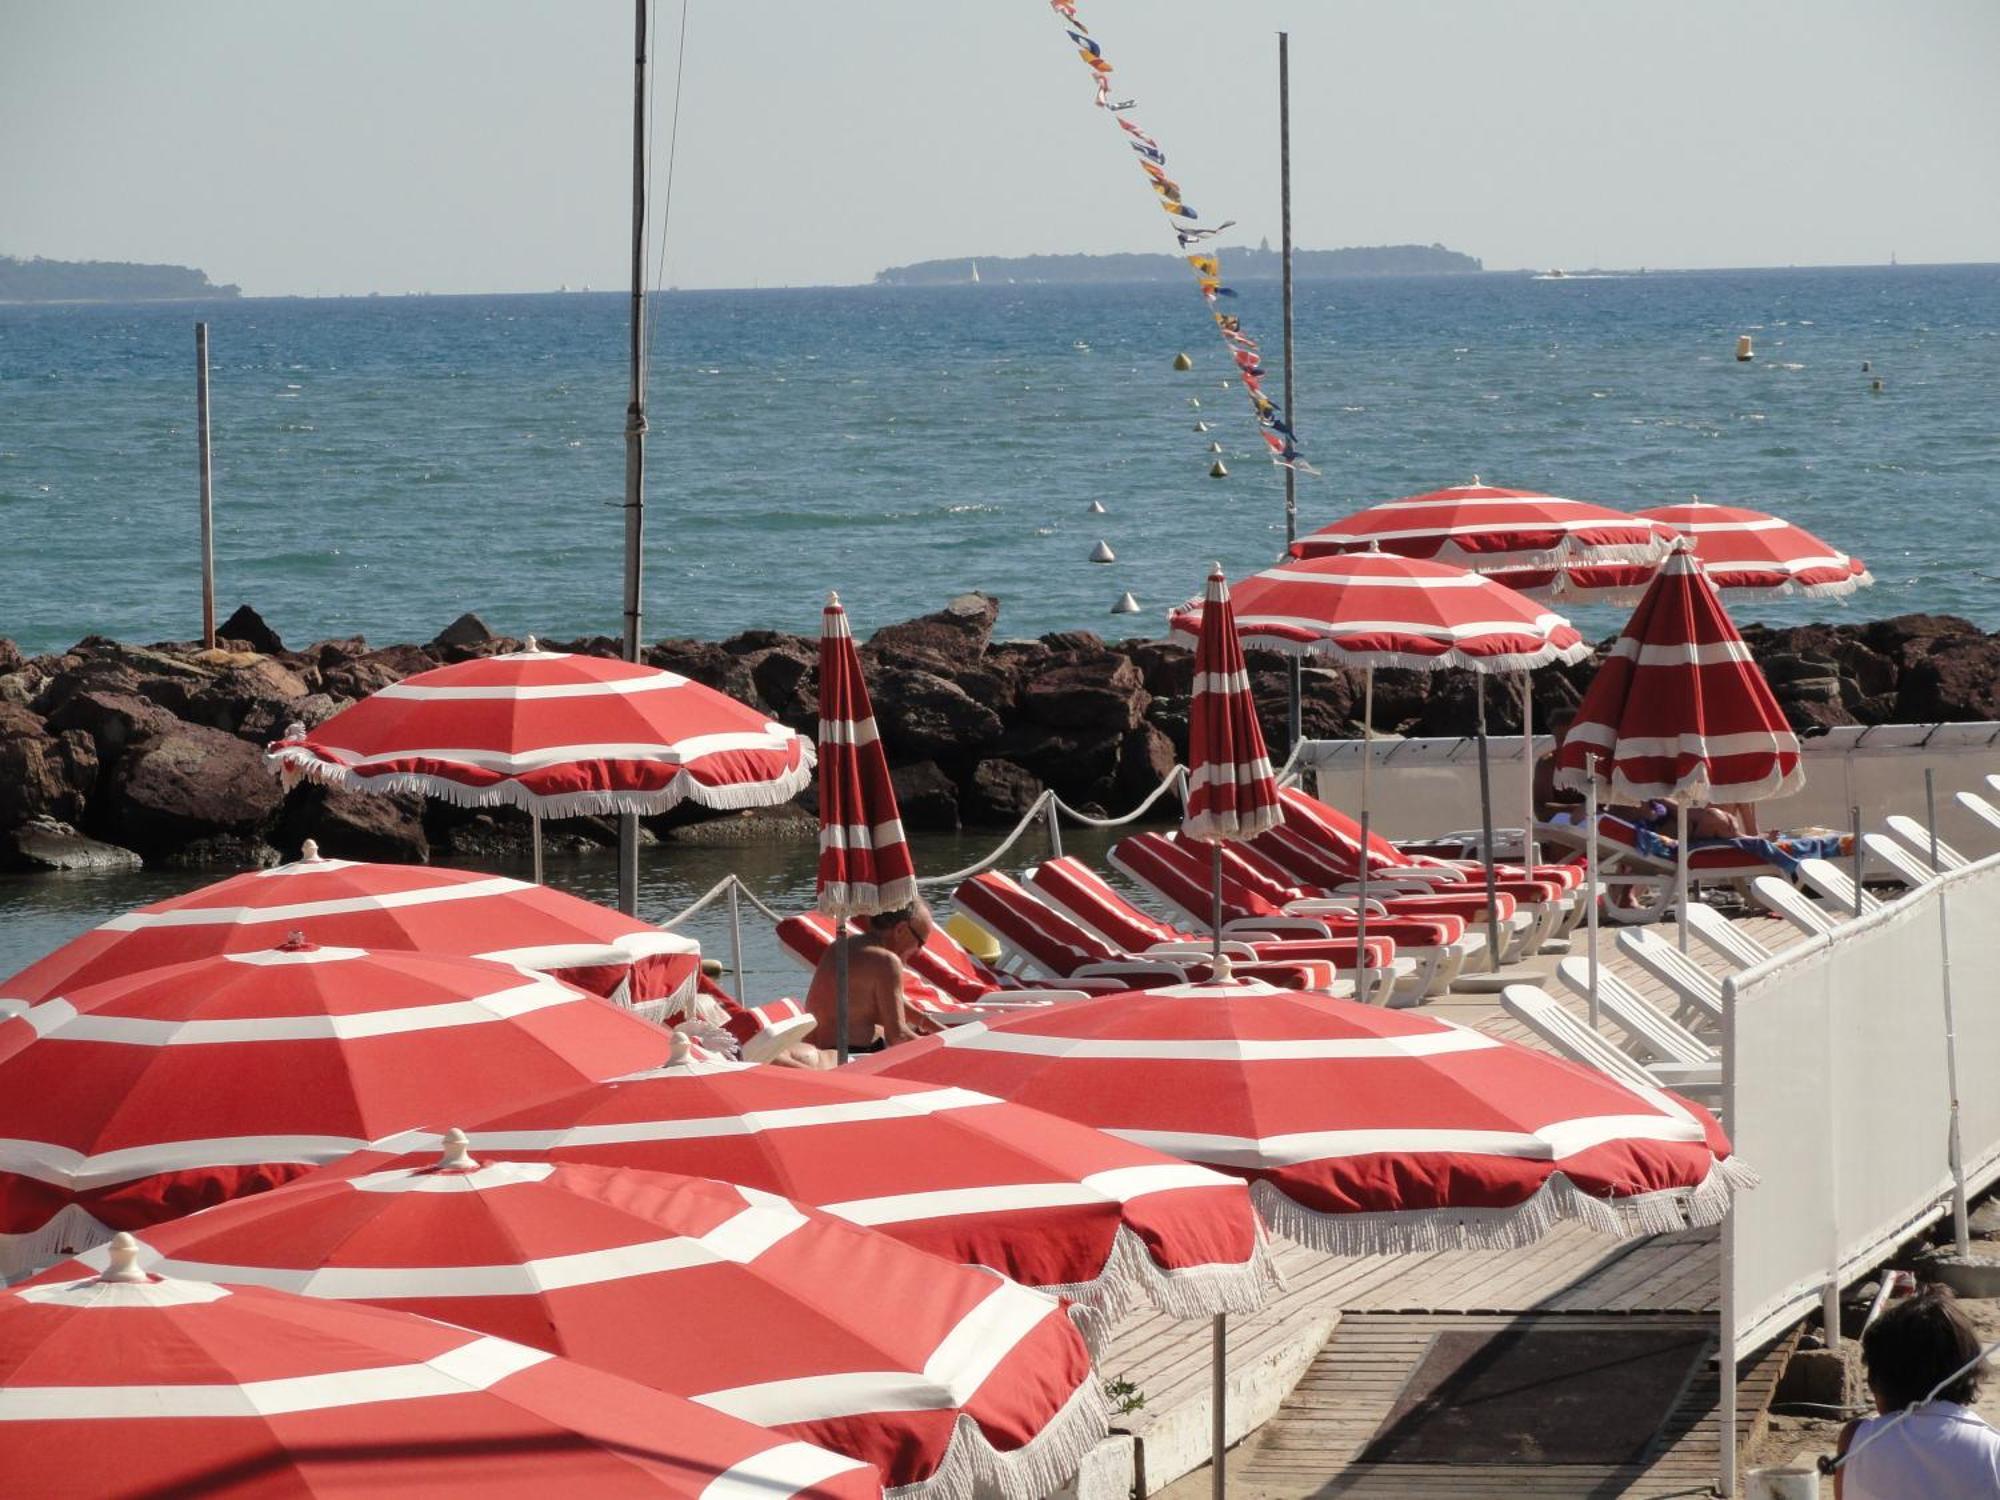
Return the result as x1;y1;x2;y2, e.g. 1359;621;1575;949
1722;856;2000;1478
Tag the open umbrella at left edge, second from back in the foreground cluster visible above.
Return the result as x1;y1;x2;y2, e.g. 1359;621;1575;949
0;942;672;1274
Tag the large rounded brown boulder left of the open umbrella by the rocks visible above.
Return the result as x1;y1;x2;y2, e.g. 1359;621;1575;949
106;728;284;858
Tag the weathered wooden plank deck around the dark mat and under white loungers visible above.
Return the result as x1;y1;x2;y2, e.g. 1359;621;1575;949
1100;918;1798;1500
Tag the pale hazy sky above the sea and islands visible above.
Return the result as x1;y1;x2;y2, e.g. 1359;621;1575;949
0;0;2000;294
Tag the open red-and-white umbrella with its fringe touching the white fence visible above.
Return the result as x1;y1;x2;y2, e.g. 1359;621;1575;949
856;980;1754;1254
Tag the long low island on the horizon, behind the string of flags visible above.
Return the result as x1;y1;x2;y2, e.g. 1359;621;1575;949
876;240;1486;286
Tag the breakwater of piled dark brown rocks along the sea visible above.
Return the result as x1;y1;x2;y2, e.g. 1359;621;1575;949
0;594;2000;870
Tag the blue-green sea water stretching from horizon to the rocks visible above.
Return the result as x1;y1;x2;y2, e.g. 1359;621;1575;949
0;266;2000;980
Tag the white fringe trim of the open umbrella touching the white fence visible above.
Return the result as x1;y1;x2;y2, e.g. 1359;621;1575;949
1250;1156;1758;1256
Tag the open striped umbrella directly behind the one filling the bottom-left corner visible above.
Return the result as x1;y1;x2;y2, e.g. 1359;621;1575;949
62;1136;1106;1500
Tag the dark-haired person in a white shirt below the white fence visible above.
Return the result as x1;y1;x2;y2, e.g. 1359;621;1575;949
1834;1286;2000;1500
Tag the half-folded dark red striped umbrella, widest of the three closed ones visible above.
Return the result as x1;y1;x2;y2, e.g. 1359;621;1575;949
1556;542;1806;806
